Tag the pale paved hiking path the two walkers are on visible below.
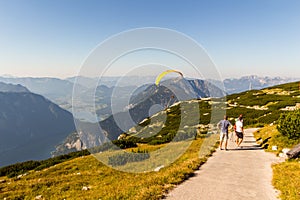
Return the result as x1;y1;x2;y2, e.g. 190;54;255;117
165;128;281;200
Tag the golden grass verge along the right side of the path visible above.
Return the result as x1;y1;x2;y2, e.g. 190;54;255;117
254;126;300;200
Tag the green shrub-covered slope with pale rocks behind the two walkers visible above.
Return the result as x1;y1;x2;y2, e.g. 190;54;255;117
117;82;300;144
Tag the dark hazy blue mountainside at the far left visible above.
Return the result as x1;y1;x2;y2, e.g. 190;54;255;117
0;83;75;166
